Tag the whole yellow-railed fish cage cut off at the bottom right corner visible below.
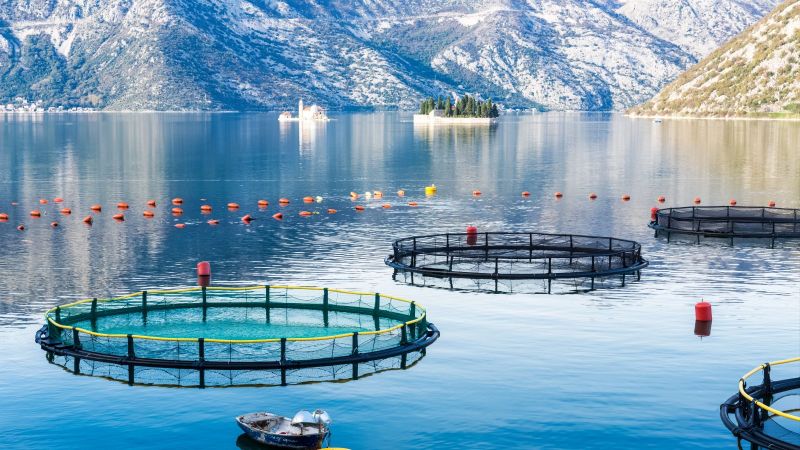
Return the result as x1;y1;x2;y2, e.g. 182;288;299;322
720;358;800;450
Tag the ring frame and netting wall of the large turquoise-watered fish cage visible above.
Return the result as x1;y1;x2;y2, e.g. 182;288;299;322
36;285;440;387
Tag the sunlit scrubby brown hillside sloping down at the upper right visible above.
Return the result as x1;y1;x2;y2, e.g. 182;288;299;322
631;0;800;116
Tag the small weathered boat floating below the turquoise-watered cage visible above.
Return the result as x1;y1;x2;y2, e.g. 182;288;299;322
236;409;331;449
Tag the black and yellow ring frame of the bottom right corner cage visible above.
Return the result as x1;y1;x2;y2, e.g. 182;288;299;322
720;357;800;450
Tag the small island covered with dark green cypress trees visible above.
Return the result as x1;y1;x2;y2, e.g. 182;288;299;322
414;95;500;125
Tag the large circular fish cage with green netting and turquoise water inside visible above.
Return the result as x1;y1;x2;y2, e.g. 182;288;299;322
36;286;439;387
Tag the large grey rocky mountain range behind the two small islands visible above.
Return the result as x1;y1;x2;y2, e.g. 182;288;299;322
0;0;777;110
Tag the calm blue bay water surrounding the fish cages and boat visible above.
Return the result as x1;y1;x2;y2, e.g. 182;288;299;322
0;113;800;449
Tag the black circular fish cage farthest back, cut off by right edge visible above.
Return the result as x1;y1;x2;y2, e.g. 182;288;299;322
649;206;800;247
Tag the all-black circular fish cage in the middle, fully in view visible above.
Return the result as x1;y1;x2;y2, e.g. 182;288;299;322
385;232;648;294
